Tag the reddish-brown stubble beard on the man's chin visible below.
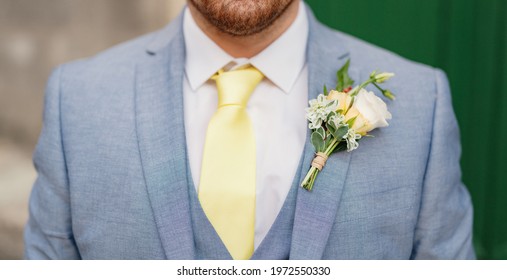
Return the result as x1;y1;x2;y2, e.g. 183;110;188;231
189;0;297;36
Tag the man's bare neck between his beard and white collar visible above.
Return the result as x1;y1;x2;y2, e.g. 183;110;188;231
188;1;300;58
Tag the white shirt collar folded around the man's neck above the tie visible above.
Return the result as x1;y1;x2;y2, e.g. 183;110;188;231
183;0;308;93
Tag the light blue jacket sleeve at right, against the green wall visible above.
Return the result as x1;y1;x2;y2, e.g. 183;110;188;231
411;70;475;259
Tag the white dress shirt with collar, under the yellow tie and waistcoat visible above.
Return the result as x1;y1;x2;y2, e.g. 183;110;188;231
183;3;308;249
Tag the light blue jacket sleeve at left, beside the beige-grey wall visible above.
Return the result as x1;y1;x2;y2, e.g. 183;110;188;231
24;68;80;259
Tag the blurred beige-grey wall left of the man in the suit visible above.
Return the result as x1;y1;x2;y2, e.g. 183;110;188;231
0;0;184;259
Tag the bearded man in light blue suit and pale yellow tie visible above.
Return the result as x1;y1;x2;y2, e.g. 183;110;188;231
25;0;474;259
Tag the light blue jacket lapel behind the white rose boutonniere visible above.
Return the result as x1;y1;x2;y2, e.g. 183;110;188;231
290;7;359;259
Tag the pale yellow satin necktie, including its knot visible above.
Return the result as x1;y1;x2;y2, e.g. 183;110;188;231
199;67;264;260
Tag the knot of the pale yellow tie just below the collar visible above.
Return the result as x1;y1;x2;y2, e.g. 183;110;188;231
212;67;264;108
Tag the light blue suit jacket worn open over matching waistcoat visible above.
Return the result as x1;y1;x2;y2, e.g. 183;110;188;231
25;7;474;259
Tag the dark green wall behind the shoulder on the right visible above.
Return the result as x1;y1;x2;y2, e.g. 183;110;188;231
306;0;507;259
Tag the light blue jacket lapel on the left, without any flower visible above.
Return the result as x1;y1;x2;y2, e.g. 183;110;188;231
136;16;195;259
